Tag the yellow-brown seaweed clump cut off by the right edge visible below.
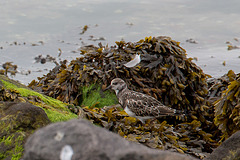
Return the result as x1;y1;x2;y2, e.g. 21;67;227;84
210;70;240;142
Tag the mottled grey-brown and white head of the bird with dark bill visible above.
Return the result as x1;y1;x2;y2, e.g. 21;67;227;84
104;78;127;95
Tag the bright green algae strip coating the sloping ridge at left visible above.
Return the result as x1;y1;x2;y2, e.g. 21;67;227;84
1;80;77;122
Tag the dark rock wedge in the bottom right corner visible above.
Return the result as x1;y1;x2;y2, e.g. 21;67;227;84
205;131;240;160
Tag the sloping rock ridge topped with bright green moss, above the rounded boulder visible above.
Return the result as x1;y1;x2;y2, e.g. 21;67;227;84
0;75;77;122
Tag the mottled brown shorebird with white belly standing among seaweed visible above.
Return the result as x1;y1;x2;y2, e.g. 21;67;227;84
104;78;182;124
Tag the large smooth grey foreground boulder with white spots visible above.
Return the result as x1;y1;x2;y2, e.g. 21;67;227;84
24;120;194;160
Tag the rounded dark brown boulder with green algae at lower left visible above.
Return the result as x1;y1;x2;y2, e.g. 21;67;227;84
0;102;50;160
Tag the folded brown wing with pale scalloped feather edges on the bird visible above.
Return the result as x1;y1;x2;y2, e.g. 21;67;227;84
125;91;176;117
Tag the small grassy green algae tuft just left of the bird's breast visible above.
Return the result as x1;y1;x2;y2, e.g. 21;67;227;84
80;84;118;108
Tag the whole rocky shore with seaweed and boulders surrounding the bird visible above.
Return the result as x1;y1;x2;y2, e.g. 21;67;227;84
0;37;240;160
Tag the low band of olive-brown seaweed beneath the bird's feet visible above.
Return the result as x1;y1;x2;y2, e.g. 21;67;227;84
80;106;214;159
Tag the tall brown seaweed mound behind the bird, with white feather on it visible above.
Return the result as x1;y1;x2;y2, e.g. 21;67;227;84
29;36;208;122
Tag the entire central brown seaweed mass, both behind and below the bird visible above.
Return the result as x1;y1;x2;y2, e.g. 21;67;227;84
29;36;221;158
